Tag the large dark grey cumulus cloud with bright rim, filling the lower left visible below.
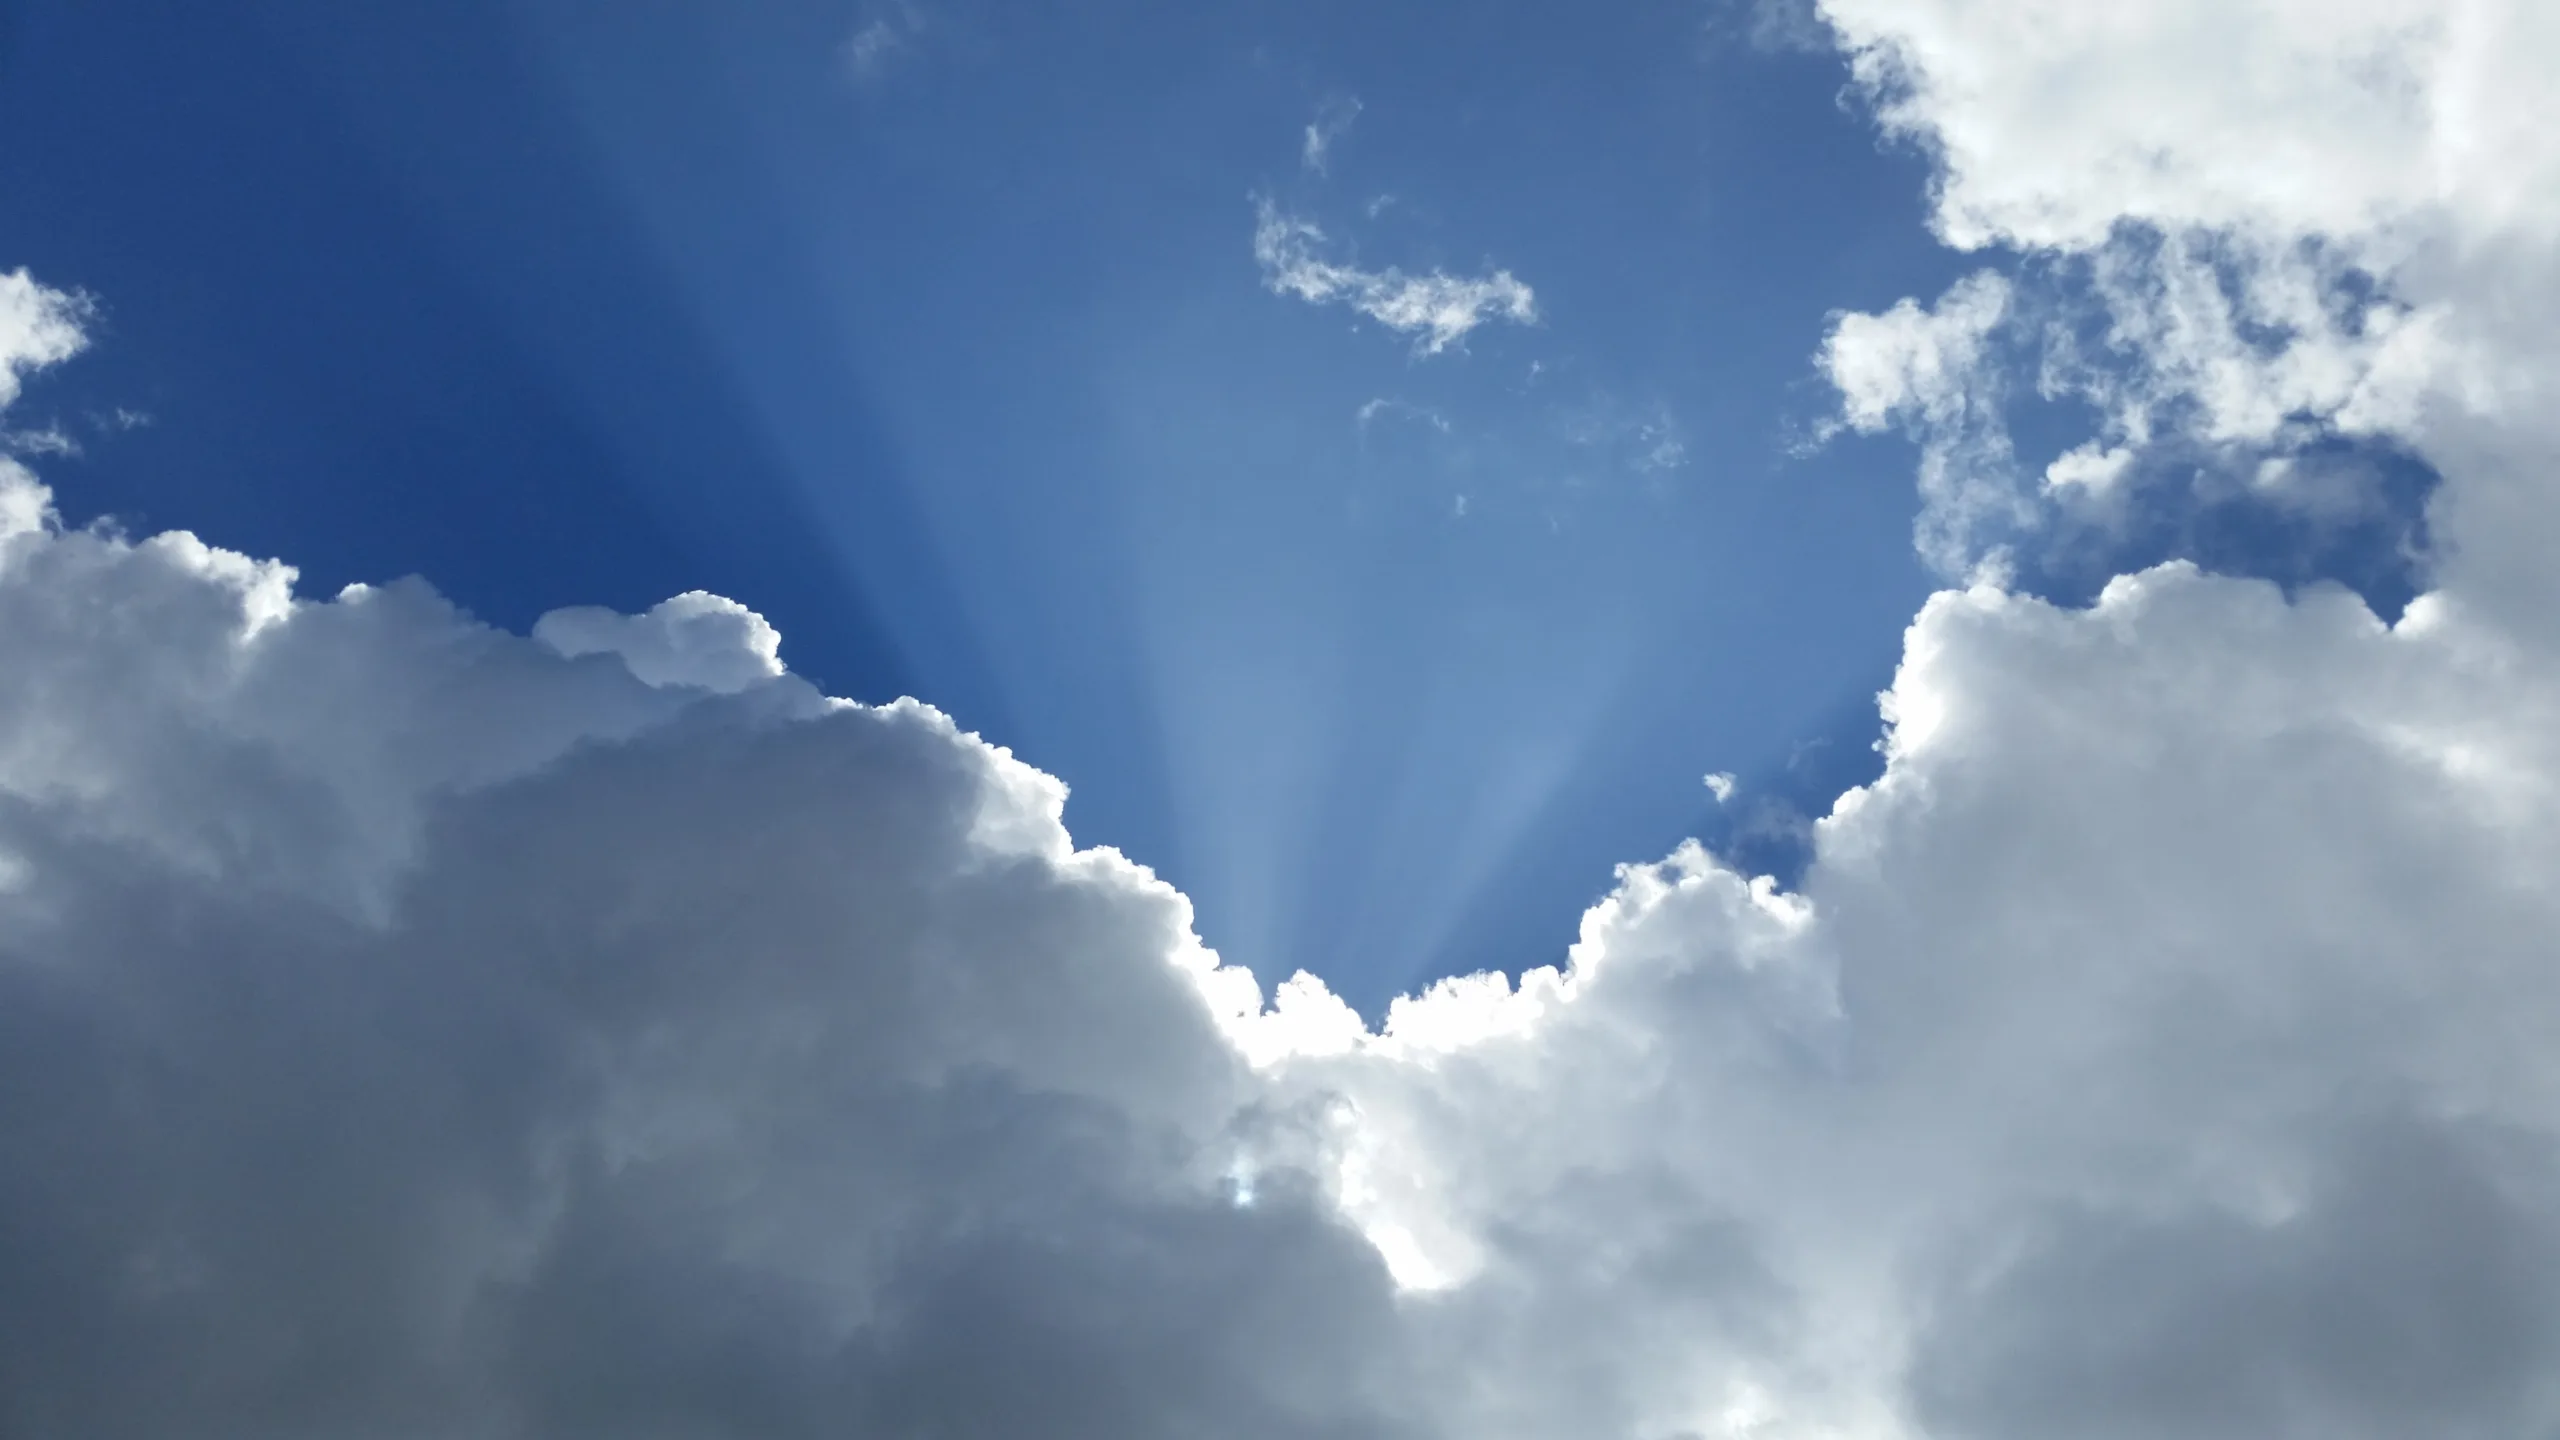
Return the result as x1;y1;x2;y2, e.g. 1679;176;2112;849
0;440;1423;1435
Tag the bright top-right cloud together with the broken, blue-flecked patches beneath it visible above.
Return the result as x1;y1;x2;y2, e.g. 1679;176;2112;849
1823;0;2560;597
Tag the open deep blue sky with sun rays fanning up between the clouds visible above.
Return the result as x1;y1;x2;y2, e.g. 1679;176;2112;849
0;0;1966;1012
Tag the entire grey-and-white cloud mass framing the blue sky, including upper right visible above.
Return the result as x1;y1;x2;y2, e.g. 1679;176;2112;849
0;0;2560;1440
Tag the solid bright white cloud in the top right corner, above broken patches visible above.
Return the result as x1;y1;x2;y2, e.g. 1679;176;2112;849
1823;0;2560;249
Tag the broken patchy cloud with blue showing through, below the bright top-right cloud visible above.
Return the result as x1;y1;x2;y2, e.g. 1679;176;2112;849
1818;231;2470;577
